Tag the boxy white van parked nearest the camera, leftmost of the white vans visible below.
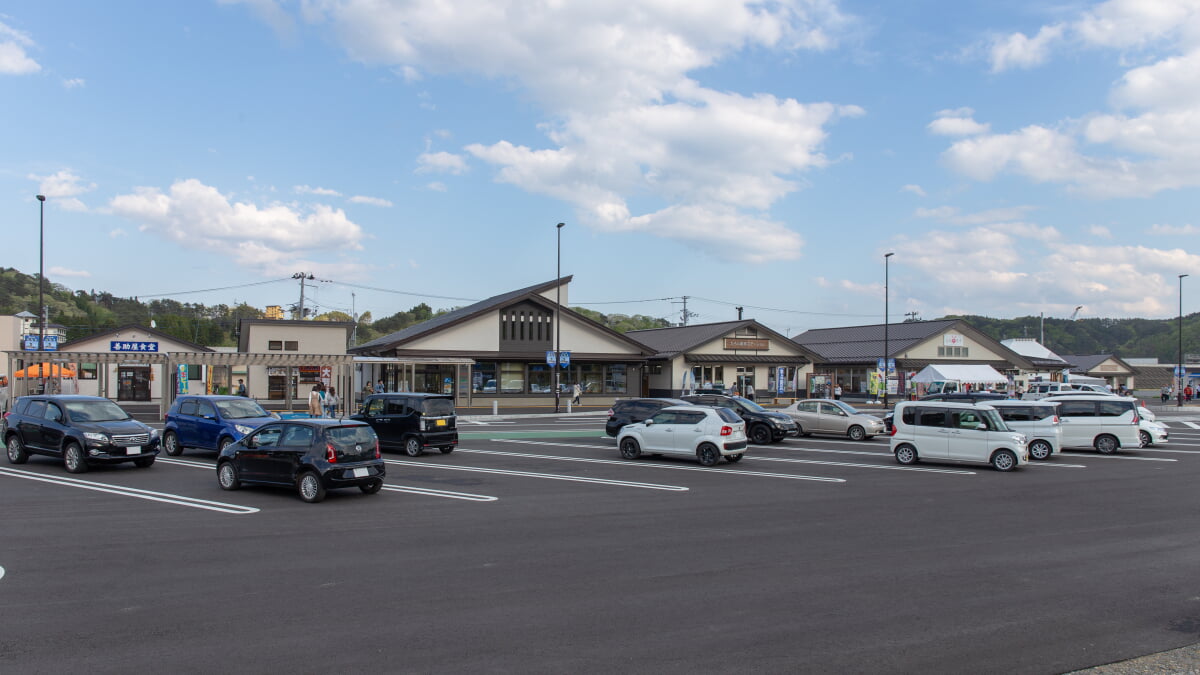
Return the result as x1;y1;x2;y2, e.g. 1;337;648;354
892;401;1030;471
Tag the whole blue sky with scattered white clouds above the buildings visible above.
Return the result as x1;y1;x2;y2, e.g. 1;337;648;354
0;0;1200;335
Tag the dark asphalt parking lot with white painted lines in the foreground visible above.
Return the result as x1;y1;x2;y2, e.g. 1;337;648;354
0;412;1200;673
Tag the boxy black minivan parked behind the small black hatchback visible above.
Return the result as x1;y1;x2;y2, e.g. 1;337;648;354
350;392;458;458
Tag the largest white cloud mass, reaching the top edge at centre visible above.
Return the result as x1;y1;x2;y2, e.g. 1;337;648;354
273;0;863;261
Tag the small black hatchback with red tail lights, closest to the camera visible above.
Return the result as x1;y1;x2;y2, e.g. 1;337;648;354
217;418;386;502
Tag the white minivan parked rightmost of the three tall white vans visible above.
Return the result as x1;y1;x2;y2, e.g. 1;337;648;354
1043;393;1141;455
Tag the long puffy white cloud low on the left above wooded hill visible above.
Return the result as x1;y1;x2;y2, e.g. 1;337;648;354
110;179;365;274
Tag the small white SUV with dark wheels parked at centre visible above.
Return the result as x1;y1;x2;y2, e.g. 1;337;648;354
617;406;746;466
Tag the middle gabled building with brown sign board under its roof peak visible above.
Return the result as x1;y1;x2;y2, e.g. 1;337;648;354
625;319;816;401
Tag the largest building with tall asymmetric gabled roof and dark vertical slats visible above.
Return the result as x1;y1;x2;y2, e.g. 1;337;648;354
349;276;652;405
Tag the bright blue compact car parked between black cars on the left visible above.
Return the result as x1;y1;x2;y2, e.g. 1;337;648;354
162;395;278;456
